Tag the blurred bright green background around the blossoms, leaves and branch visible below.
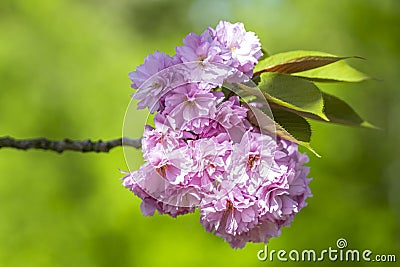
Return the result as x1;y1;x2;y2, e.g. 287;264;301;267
0;0;400;267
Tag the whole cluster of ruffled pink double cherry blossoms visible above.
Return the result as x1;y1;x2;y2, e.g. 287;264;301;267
123;21;311;248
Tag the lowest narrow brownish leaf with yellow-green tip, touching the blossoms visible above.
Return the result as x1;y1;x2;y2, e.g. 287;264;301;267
248;107;321;157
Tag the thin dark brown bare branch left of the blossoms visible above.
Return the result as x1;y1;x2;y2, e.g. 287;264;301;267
0;136;142;153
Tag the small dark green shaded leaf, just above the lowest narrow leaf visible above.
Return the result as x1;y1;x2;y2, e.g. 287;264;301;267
272;109;311;143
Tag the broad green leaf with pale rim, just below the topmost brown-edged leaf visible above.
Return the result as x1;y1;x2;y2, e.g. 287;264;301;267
258;72;329;121
